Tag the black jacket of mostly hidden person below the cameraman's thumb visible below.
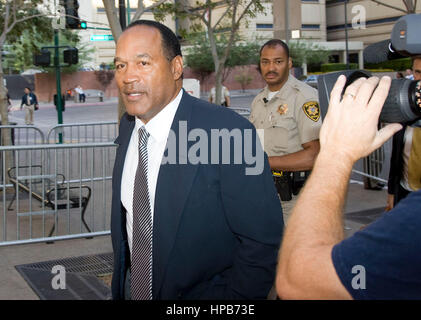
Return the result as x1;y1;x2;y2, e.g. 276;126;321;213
387;126;407;204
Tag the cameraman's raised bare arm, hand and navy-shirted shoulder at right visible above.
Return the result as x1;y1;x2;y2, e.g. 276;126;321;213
276;75;421;299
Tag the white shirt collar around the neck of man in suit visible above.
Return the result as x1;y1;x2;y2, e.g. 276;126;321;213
135;90;183;142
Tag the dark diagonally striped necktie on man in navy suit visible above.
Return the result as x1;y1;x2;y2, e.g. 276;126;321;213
131;127;152;300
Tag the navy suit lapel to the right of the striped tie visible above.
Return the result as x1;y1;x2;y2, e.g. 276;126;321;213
153;92;198;297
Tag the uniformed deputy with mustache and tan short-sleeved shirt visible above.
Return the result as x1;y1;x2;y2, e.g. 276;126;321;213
249;39;322;220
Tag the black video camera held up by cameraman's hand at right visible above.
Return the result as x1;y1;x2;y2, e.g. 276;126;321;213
318;14;421;127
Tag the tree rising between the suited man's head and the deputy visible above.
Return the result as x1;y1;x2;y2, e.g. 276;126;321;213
153;0;264;104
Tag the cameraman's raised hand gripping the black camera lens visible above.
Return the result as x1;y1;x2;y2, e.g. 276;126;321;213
320;75;402;163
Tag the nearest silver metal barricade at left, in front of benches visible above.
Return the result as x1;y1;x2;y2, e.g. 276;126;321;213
0;142;116;246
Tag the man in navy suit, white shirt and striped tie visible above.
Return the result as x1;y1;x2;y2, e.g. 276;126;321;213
111;20;283;300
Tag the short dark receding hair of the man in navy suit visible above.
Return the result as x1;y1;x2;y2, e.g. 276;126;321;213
126;20;182;61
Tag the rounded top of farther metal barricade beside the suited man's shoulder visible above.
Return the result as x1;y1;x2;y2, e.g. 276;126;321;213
47;121;118;143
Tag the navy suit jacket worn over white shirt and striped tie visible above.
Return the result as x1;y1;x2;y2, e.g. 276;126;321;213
111;92;284;299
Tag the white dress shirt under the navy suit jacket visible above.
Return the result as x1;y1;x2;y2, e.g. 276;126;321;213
121;90;183;252
